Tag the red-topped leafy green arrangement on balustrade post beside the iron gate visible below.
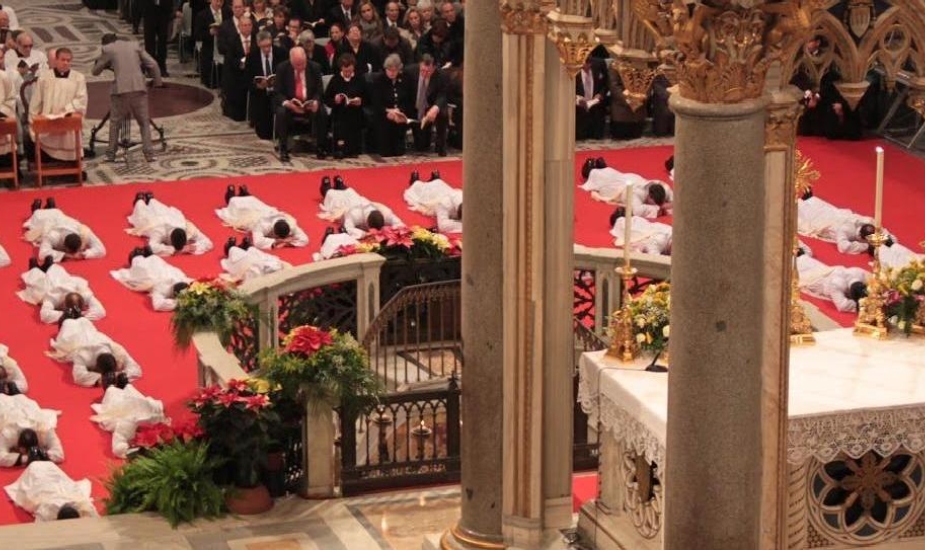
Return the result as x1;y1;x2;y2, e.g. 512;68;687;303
260;325;383;412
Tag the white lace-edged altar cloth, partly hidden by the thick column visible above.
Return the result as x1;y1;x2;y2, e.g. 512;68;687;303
578;329;925;470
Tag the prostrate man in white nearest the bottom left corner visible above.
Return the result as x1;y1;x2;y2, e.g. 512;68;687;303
4;461;99;521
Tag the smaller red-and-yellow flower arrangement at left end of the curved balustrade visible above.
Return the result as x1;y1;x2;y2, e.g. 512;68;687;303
170;279;253;349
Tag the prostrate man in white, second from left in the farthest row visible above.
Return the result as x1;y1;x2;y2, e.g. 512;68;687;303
126;193;212;256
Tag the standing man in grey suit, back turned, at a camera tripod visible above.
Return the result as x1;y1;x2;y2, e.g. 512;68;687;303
92;34;163;162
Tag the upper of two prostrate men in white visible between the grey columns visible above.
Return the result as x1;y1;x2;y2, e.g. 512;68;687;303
581;159;673;219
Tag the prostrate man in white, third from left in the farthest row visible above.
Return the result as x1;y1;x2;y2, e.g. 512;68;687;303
215;189;308;250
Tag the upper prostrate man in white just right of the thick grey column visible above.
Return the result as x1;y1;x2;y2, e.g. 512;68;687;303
797;192;896;254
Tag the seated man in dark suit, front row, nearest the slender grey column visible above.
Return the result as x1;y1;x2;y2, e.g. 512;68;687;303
405;54;449;157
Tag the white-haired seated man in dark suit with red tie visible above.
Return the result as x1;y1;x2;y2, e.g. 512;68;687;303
273;46;328;162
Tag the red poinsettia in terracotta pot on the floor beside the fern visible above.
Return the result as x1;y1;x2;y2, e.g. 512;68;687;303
189;380;279;514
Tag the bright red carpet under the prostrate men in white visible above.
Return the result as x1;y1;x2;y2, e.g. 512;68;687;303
0;140;925;524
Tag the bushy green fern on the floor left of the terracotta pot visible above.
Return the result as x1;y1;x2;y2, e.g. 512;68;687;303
105;440;225;527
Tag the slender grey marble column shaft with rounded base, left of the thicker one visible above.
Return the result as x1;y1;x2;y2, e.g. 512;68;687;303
441;1;504;548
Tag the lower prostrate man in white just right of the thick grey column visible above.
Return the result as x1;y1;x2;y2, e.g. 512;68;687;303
797;254;870;311
